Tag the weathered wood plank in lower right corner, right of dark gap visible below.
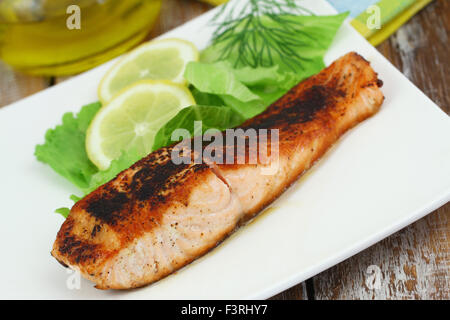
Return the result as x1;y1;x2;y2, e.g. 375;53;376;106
314;205;450;300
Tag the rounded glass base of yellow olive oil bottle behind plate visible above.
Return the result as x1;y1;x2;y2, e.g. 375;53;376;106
0;0;161;75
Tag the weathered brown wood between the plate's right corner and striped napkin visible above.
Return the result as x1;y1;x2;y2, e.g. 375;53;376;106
378;0;450;113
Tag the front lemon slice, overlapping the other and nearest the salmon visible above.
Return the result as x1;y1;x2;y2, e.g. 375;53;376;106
86;80;195;170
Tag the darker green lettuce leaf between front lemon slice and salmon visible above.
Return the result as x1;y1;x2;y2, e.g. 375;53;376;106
153;106;245;150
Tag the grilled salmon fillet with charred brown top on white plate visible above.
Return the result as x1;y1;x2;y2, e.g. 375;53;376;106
52;53;384;289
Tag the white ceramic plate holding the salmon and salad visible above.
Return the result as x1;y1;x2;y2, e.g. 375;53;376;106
0;0;450;299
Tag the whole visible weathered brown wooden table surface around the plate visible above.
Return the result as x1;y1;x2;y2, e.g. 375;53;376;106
0;0;450;299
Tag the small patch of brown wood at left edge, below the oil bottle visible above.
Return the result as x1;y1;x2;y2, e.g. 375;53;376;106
0;62;48;108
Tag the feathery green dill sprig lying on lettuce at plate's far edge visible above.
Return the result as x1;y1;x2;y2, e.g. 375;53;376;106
212;0;313;71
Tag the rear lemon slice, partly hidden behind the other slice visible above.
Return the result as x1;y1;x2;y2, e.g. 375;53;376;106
98;39;199;103
